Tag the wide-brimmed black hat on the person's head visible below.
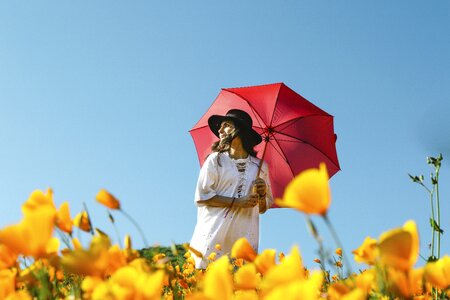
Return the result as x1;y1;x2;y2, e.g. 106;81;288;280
208;109;262;145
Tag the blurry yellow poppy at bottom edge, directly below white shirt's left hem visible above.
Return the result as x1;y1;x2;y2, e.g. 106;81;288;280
203;256;233;300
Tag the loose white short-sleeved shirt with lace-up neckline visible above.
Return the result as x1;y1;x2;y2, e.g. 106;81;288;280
190;152;273;268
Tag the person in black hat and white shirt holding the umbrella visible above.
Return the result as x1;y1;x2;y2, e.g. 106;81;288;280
190;109;273;269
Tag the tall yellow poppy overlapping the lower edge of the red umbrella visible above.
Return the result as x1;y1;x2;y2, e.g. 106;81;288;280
276;163;331;215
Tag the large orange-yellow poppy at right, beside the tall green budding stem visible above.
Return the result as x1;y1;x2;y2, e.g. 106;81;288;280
378;221;419;271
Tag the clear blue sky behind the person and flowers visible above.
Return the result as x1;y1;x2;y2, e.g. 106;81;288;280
0;0;450;267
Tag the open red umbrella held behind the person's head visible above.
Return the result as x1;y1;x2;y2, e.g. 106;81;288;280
189;83;340;204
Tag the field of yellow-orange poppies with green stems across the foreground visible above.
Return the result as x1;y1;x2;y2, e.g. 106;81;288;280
0;156;450;300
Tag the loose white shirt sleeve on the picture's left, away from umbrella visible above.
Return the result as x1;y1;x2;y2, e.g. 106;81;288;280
195;153;218;203
